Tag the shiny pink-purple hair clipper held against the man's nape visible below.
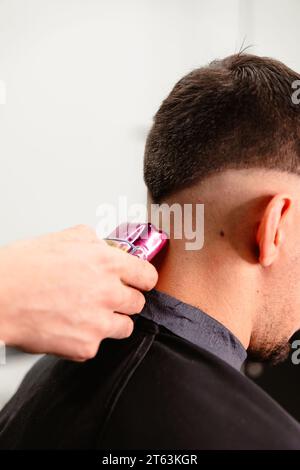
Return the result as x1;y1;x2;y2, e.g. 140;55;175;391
106;222;168;261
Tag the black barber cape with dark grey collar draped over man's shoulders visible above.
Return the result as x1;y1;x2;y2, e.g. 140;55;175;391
0;290;300;450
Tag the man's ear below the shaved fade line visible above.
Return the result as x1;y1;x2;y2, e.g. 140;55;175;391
256;194;292;267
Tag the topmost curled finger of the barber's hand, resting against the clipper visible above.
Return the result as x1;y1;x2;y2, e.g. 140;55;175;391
112;248;158;290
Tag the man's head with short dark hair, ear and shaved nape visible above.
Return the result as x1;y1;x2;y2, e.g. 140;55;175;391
144;54;300;364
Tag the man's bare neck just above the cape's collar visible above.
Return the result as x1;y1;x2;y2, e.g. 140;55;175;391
155;240;253;349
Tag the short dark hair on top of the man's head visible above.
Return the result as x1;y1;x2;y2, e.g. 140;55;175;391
144;53;300;203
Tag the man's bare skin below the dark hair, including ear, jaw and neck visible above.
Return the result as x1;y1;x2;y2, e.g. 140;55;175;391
152;169;300;362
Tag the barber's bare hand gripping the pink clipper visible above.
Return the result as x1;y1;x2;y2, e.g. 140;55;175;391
0;226;157;361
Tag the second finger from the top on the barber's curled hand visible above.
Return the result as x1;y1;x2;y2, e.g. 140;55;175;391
113;282;145;315
